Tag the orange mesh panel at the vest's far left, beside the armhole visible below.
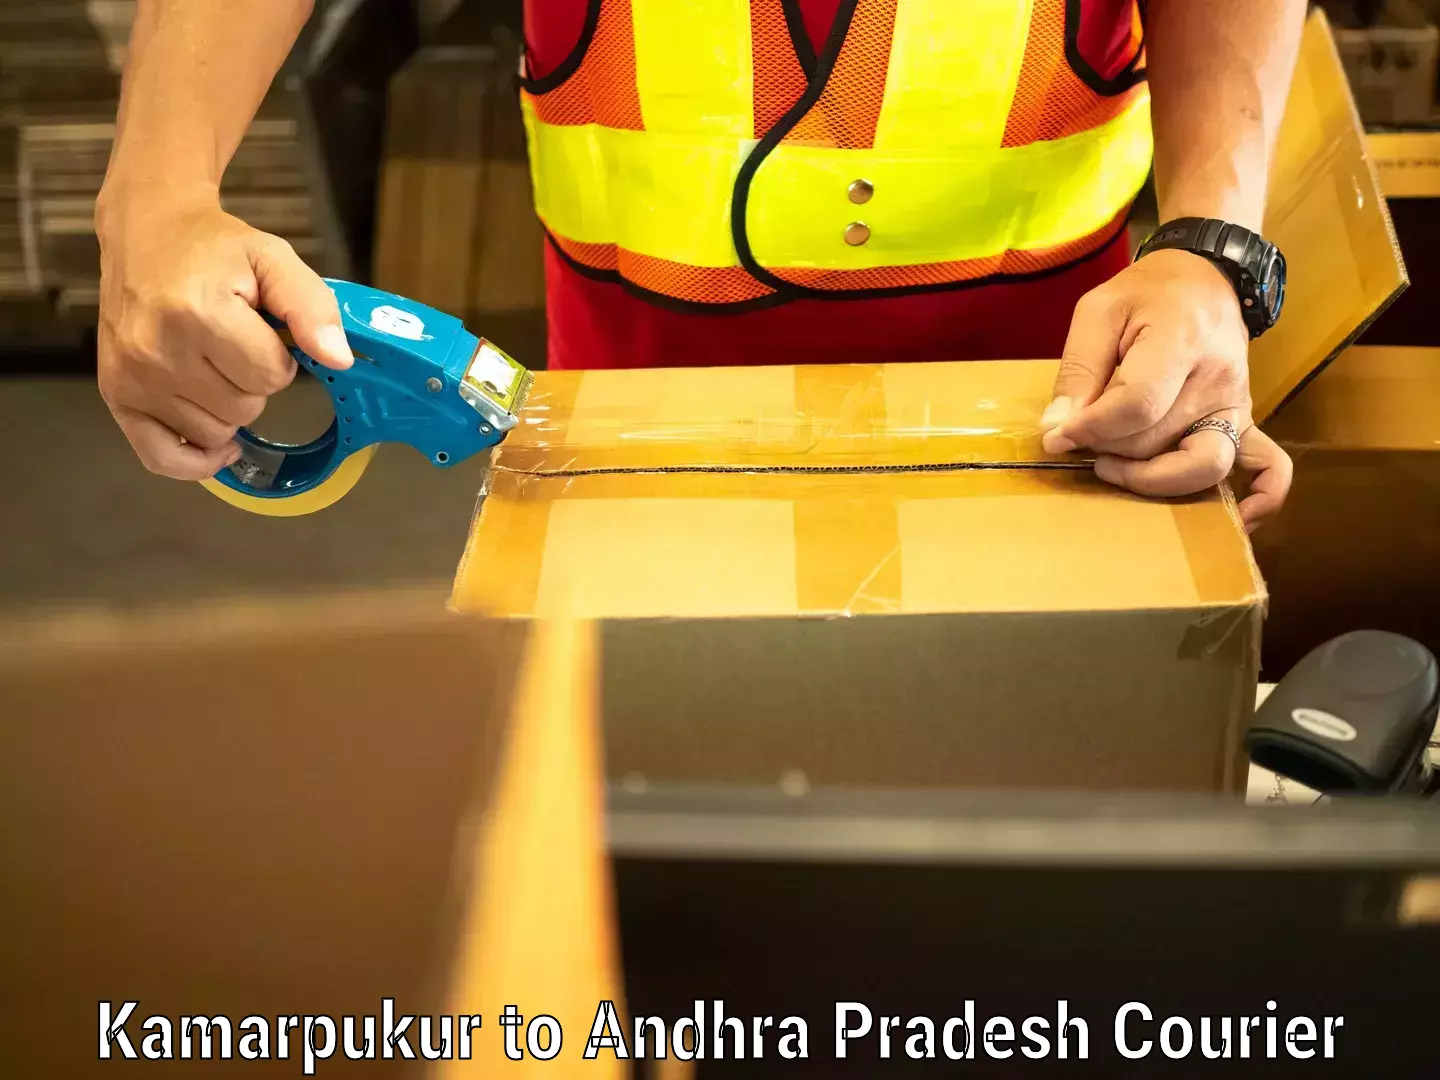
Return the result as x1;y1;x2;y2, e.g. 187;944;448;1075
526;0;645;131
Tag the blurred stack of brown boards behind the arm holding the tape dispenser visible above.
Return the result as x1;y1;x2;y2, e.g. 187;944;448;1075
0;0;348;333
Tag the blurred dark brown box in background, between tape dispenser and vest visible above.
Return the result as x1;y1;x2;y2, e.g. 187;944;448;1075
373;39;544;366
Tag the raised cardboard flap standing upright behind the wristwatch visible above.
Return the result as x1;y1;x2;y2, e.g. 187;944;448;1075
1250;9;1408;423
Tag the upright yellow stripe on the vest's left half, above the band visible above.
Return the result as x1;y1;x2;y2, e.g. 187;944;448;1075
631;0;755;138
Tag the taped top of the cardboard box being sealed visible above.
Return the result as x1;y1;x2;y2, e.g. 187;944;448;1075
454;364;1263;624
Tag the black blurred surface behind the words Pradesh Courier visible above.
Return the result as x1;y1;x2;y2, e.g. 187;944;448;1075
616;860;1440;1080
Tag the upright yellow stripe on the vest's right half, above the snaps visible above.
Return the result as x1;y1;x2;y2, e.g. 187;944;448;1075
876;0;1036;151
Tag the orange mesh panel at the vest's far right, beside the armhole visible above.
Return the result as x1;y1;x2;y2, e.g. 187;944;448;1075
1001;0;1146;147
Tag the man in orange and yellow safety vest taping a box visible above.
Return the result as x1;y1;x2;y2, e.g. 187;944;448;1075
96;0;1305;528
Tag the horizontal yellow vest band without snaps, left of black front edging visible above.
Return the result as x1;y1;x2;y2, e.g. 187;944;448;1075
524;101;752;266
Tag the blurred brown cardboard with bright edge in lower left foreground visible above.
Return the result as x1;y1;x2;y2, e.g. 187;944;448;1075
0;593;618;1080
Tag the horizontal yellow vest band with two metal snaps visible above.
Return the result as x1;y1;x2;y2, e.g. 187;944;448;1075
746;95;1152;269
